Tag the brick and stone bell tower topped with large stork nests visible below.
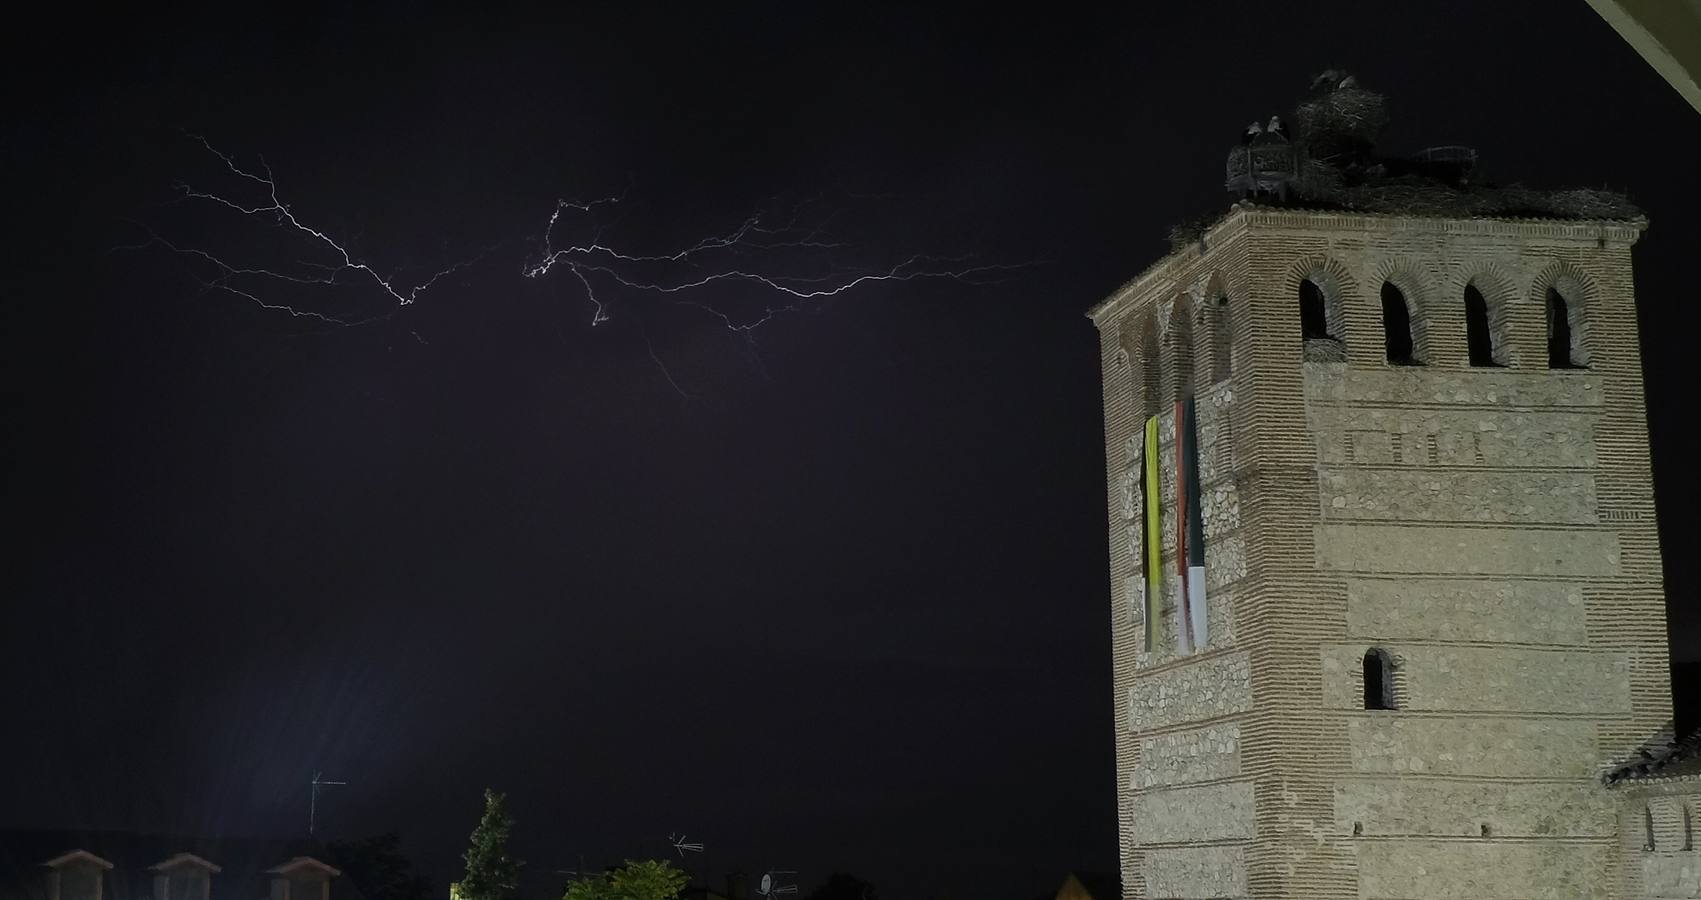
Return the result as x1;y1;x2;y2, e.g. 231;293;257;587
1090;73;1666;900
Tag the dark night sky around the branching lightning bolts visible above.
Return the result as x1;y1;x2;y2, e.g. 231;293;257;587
0;0;1701;900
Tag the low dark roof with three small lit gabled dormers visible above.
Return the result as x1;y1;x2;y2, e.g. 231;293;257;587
0;830;366;900
